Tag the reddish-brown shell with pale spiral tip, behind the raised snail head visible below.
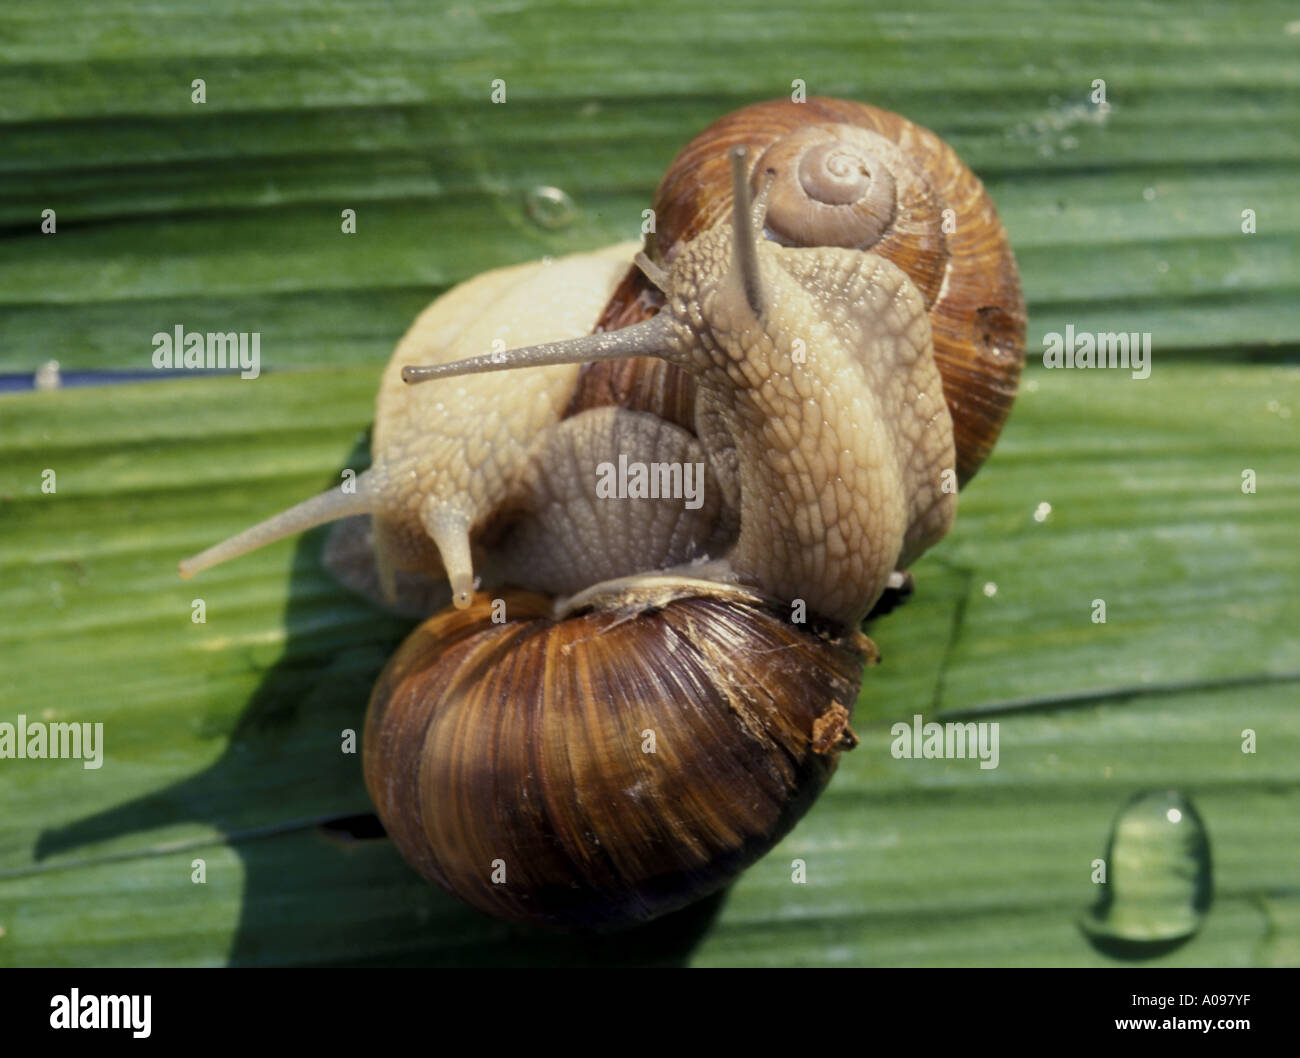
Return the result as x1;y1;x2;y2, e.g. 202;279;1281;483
568;97;1026;484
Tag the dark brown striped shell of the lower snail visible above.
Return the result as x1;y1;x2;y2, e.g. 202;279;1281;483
363;589;875;929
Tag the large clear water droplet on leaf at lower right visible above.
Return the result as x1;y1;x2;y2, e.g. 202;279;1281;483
1080;790;1213;958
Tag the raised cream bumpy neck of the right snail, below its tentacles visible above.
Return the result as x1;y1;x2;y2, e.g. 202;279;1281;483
697;244;954;625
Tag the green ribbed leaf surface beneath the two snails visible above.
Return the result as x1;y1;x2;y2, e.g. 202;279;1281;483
0;0;1300;966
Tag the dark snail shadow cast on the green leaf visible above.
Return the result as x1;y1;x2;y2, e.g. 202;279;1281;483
35;441;725;966
